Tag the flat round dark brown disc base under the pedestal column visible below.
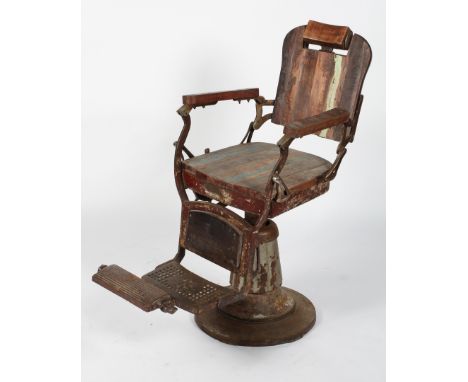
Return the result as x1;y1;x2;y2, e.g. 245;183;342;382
195;288;315;346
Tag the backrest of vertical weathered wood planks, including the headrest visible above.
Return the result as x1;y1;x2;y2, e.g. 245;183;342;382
272;21;372;140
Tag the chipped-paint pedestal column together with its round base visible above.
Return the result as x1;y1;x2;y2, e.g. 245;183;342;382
195;216;315;346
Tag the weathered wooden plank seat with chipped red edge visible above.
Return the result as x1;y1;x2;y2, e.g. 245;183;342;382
183;142;331;216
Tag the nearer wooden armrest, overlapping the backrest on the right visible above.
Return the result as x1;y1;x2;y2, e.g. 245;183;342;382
283;108;349;138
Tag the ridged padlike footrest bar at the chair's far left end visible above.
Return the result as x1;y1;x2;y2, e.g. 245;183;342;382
93;265;177;313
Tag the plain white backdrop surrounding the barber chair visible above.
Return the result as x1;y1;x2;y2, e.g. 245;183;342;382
82;0;385;382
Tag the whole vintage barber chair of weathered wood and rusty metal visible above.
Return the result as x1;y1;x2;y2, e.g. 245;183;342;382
93;21;371;346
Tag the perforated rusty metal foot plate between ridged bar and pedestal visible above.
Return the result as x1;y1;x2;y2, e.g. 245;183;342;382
142;260;235;314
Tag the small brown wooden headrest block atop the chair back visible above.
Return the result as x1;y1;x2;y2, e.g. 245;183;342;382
303;20;353;49
